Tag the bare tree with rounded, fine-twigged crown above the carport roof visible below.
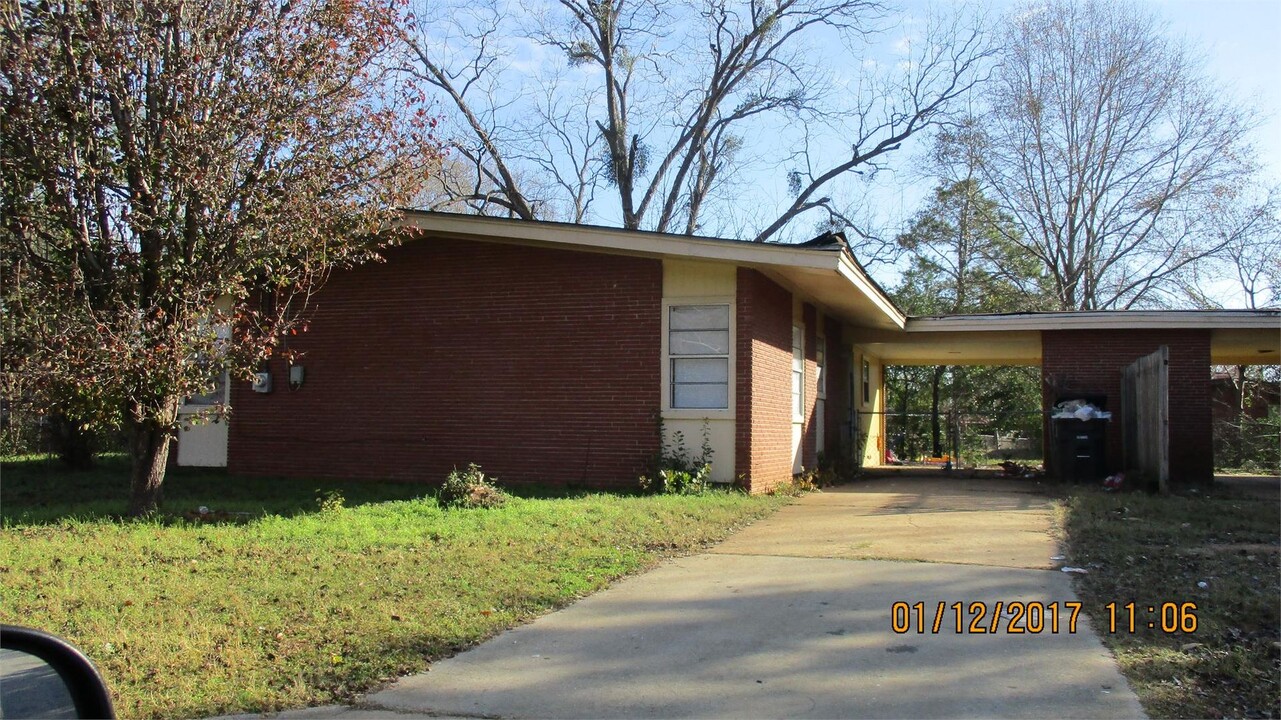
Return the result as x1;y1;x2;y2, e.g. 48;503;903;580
983;0;1253;310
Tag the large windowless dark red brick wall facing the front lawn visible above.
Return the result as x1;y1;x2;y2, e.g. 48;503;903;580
228;238;662;487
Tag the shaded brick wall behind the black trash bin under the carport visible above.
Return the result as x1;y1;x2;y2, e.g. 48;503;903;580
1041;329;1214;484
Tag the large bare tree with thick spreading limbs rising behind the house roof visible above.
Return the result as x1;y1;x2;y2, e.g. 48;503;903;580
405;0;988;241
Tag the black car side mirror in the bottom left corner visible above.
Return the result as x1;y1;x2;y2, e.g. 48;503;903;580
0;625;115;720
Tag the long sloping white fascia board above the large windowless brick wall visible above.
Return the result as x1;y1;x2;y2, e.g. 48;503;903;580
400;213;839;269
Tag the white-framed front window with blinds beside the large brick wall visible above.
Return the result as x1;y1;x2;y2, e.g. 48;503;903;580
667;299;729;410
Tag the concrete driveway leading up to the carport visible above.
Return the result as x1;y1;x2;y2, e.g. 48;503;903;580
217;477;1143;719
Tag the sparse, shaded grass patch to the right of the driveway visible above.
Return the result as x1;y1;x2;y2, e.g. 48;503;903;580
1063;479;1281;717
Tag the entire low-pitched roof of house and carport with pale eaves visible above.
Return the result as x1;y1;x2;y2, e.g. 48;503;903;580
401;210;1281;365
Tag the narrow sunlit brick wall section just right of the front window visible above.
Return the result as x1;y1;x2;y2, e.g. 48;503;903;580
734;268;792;493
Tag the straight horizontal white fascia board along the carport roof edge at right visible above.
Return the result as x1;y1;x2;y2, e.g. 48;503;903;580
906;310;1281;332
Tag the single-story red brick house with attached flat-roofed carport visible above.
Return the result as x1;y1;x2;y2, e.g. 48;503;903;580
177;213;1278;492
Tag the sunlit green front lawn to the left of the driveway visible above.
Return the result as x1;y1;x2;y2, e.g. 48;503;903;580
0;459;784;717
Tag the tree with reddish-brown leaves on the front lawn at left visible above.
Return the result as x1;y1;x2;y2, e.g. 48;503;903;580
0;0;436;515
